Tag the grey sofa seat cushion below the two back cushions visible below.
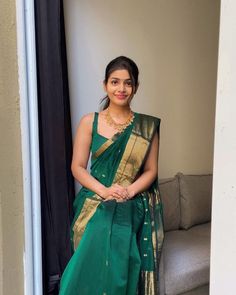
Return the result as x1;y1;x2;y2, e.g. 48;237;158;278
163;222;211;295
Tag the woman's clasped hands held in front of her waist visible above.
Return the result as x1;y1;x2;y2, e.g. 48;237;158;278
102;183;132;202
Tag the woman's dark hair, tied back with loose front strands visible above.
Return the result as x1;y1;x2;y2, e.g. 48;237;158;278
100;55;139;110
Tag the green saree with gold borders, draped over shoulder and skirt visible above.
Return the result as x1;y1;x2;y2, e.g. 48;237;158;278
59;113;164;295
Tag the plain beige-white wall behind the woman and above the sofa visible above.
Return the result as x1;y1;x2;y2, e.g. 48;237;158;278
64;0;219;183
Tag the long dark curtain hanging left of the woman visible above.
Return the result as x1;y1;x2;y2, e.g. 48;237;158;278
35;0;75;294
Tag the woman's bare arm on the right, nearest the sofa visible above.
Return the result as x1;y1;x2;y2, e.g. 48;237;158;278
127;133;159;198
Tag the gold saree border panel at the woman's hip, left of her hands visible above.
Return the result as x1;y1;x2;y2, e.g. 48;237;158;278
73;194;102;250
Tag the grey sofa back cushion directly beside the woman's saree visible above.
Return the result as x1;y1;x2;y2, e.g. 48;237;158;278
159;177;180;231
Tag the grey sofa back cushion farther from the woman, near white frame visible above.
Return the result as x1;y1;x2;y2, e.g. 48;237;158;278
176;172;212;229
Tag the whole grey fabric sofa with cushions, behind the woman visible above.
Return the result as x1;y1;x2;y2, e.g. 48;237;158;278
159;172;212;295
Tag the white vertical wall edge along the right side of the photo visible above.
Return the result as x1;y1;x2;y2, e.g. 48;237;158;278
210;0;236;295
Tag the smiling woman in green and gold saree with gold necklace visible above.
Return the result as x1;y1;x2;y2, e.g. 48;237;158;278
59;56;164;295
